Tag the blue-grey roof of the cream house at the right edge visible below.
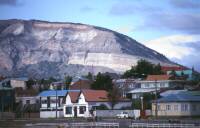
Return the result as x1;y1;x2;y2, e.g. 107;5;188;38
157;91;200;102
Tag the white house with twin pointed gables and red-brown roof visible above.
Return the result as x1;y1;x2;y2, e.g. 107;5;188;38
63;90;131;117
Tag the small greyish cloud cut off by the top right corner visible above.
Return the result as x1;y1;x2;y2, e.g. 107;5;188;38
170;0;200;9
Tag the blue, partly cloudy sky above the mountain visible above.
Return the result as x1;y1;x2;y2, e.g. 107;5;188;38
0;0;200;71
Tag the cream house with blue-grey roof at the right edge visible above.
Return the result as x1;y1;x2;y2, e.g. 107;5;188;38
152;91;200;117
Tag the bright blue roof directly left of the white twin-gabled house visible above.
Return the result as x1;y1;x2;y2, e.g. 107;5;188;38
38;90;80;97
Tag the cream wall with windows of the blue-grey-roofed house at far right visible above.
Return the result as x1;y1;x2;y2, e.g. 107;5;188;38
152;102;200;116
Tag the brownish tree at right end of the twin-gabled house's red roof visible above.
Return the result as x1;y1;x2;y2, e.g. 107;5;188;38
108;86;121;109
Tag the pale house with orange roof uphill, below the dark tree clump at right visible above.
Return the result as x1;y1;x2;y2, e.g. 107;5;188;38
139;75;181;89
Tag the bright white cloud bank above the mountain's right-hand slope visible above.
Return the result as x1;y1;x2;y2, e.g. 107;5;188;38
144;35;200;60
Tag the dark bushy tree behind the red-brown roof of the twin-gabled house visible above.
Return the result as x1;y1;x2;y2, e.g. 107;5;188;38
91;73;113;91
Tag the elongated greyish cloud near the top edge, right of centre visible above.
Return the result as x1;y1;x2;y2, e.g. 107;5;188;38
109;3;160;16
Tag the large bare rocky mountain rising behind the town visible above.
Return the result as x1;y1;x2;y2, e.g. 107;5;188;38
0;19;173;78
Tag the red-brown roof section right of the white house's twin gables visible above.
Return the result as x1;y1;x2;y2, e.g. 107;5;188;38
82;90;109;102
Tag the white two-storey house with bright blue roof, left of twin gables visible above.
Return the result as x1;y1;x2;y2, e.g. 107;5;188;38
38;90;79;118
